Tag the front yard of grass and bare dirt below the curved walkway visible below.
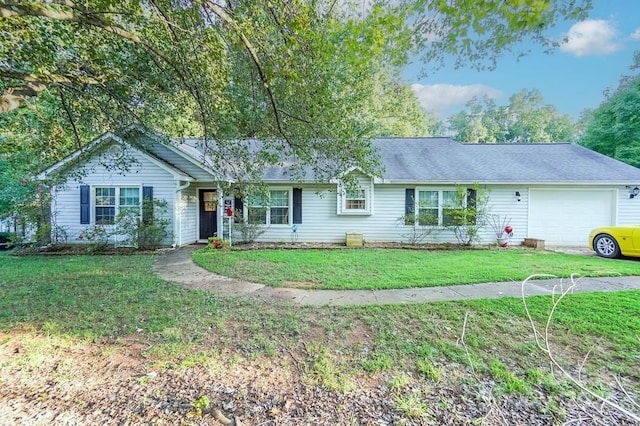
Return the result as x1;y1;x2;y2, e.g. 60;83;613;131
0;250;640;425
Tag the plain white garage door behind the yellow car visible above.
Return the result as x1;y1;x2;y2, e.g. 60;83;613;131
529;189;616;246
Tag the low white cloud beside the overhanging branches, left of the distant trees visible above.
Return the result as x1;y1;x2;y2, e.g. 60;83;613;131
411;84;503;119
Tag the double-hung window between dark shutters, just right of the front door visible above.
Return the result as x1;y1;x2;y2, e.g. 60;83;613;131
247;189;291;225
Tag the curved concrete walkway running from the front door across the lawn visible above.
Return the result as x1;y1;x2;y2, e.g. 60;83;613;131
154;246;640;306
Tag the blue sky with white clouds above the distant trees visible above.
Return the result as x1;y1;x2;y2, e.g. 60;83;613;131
403;0;640;120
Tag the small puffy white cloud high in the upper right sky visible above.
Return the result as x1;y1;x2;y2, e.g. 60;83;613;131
560;19;622;56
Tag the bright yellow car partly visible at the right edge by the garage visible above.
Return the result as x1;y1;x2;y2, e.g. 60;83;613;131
589;225;640;259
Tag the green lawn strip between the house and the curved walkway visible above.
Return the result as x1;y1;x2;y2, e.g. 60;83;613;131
193;249;640;290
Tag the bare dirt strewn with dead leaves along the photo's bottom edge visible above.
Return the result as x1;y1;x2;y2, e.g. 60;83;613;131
0;332;633;425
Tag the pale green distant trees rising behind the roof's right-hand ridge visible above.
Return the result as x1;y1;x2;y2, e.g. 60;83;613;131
449;90;576;143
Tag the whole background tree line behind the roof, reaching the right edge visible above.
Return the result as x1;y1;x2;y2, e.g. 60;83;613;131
448;53;640;171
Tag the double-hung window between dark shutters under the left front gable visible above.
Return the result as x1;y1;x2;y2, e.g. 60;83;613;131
94;186;141;225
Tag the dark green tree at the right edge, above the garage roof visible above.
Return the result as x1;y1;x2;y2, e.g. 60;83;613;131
580;52;640;167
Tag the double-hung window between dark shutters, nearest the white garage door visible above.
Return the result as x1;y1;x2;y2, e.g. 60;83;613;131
415;189;466;226
